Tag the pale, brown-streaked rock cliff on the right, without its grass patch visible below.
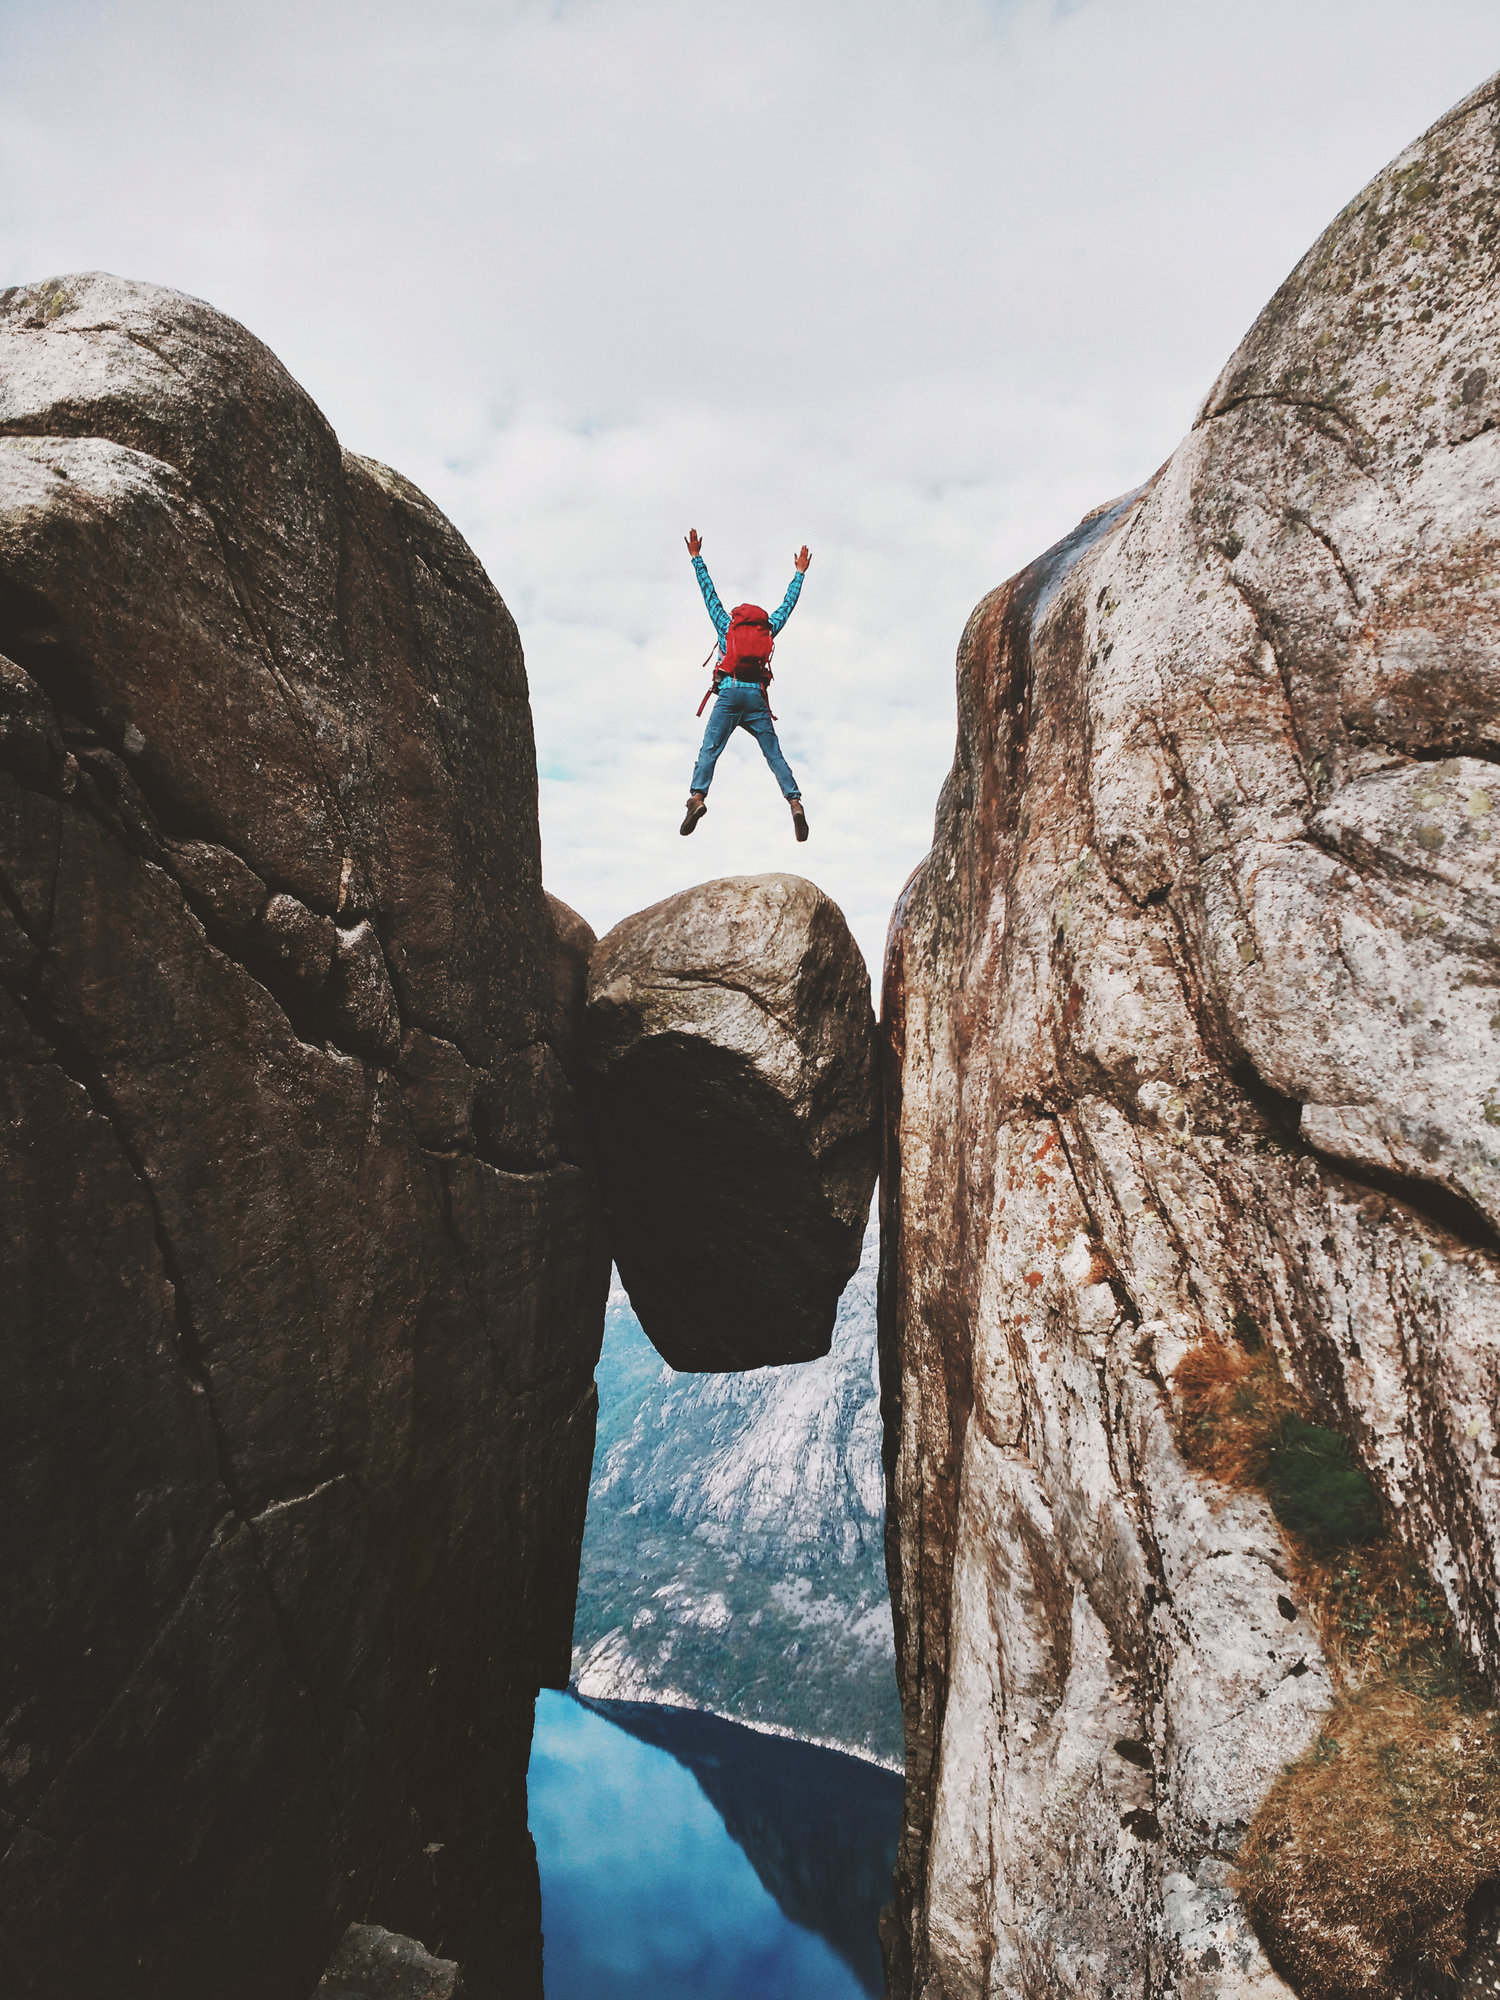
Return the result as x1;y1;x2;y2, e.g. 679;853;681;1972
882;70;1500;2000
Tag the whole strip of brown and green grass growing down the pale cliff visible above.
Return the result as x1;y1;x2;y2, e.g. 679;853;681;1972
1174;1342;1500;2000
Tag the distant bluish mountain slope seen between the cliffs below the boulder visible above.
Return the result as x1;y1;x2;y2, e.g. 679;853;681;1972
574;1228;902;1764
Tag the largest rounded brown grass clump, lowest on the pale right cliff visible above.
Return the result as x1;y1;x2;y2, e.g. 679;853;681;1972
1238;1682;1500;2000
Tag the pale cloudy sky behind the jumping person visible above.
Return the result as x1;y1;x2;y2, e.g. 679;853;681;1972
0;0;1500;958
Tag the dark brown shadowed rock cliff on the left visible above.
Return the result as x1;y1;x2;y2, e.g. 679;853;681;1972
0;276;608;2000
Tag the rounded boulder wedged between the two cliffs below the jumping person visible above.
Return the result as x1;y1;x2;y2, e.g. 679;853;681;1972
584;874;878;1370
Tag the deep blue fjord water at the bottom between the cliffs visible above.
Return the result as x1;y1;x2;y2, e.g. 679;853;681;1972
530;1694;902;2000
